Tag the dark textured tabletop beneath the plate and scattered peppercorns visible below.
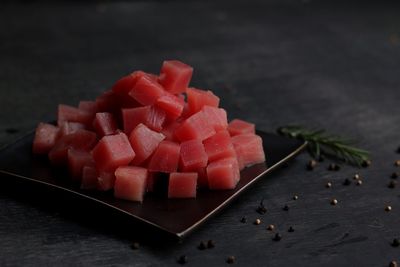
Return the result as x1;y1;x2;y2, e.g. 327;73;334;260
0;1;400;266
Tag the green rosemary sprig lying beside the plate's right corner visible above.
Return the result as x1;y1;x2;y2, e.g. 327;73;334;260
278;125;370;167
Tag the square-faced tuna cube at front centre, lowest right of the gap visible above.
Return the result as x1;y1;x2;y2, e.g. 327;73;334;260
168;172;197;198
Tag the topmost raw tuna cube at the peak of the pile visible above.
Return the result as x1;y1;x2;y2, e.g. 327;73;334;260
159;60;193;94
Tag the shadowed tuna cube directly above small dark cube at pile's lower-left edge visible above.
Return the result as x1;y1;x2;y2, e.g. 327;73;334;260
68;148;95;180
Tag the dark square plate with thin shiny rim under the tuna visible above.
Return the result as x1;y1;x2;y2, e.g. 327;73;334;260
0;132;306;240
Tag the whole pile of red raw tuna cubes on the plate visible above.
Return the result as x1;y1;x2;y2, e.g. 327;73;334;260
33;60;265;202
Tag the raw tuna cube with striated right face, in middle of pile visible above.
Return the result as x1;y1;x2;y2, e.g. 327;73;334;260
122;106;166;134
